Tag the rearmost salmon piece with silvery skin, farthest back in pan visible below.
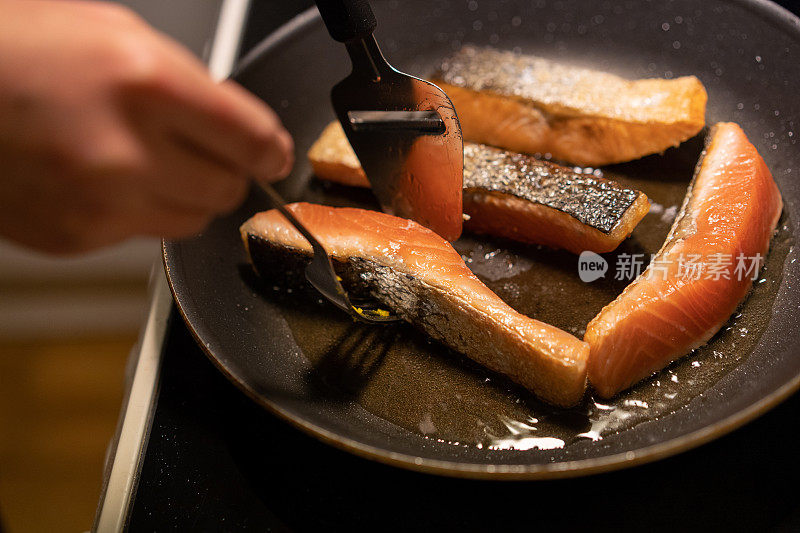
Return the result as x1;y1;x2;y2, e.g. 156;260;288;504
432;46;708;166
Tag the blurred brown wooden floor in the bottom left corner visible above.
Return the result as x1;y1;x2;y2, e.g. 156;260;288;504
0;335;136;533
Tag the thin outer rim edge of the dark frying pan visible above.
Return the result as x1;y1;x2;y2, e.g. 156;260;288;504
162;0;800;481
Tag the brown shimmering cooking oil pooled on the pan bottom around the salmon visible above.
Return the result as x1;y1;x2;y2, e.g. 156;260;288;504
270;148;793;450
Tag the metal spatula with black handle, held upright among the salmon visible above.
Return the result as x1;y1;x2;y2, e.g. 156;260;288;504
316;0;464;240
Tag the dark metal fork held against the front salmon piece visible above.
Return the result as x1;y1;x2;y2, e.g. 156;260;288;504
260;183;401;324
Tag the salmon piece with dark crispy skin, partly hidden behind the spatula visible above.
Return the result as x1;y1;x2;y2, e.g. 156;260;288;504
308;122;650;254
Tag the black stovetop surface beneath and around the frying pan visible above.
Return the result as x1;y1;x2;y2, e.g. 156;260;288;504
128;0;800;531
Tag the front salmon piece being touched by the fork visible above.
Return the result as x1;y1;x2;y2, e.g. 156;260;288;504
240;203;589;407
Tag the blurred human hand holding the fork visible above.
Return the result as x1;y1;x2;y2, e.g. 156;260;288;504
0;0;293;253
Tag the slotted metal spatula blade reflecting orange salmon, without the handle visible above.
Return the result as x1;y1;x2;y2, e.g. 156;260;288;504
331;39;464;241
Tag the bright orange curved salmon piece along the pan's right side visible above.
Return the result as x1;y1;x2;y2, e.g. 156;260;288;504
584;123;783;398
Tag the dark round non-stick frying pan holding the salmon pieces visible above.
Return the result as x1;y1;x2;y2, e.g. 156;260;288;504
164;0;800;478
